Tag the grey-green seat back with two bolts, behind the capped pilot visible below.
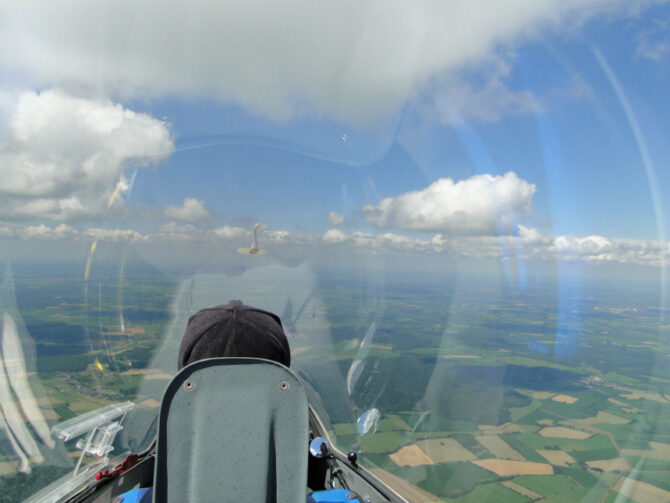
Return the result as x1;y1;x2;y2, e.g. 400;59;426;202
154;358;309;503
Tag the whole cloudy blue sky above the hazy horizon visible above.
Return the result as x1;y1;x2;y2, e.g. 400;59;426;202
0;0;670;269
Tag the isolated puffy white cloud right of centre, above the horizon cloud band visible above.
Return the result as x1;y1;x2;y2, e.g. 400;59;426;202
362;171;535;234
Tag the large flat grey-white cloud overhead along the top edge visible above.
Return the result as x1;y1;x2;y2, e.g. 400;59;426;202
0;0;651;124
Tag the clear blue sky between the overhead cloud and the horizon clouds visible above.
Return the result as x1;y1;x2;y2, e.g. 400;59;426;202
123;7;670;239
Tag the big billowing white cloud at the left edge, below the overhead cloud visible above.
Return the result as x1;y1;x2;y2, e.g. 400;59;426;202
0;89;173;221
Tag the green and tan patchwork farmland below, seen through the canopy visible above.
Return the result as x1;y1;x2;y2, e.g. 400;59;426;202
0;262;670;502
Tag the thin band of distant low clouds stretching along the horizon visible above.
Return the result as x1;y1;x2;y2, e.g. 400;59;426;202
0;222;670;267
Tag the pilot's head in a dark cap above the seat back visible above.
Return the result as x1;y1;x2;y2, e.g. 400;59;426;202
177;300;291;369
